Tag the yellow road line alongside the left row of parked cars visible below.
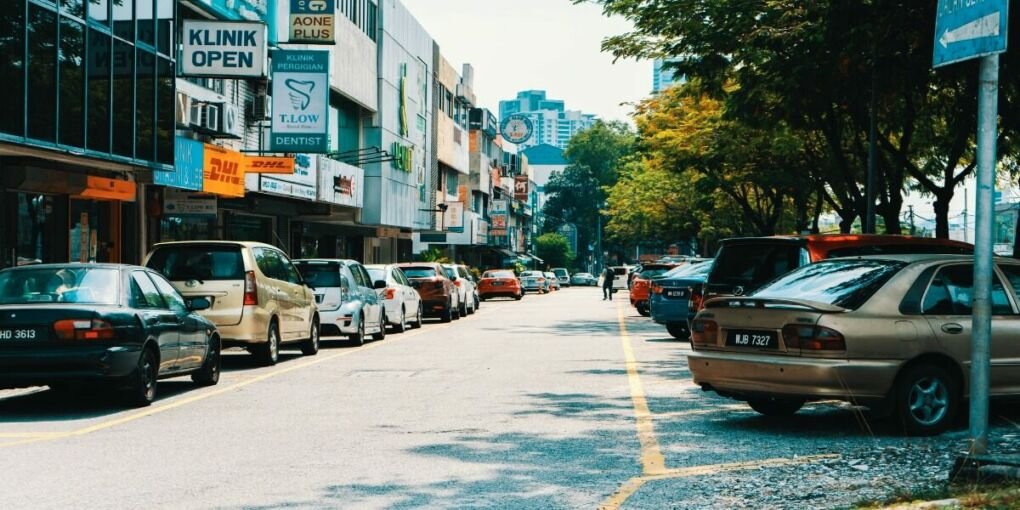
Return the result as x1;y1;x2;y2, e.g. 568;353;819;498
0;303;495;448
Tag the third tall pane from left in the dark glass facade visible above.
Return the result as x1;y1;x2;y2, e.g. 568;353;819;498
58;16;85;147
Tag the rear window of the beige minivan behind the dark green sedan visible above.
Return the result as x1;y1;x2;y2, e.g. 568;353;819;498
147;246;245;282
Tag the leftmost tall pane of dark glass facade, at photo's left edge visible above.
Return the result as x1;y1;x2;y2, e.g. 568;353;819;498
0;0;24;136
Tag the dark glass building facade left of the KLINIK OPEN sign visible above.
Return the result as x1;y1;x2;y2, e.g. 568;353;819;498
0;0;175;165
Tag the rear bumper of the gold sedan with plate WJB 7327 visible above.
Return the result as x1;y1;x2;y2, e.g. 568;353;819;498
687;351;902;401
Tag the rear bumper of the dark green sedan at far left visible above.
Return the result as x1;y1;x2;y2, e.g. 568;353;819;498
0;345;142;388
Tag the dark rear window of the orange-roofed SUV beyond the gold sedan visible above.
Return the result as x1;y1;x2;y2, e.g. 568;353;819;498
708;243;807;291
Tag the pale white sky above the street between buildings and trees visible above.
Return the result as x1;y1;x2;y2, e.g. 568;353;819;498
402;0;652;120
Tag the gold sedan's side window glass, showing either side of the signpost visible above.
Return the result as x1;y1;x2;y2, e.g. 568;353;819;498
921;265;1013;315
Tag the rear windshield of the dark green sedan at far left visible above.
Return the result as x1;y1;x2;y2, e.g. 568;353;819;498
0;266;120;305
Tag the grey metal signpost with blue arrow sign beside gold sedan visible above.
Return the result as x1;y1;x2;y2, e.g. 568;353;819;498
932;0;1009;455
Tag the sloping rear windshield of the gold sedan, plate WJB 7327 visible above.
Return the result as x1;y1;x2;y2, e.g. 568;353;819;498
752;260;907;310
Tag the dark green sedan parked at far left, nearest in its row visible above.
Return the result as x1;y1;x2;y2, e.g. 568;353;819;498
0;263;220;406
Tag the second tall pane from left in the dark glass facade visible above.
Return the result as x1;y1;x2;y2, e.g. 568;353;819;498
27;4;57;142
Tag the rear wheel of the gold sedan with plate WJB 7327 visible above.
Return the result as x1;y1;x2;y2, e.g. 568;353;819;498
896;364;961;436
